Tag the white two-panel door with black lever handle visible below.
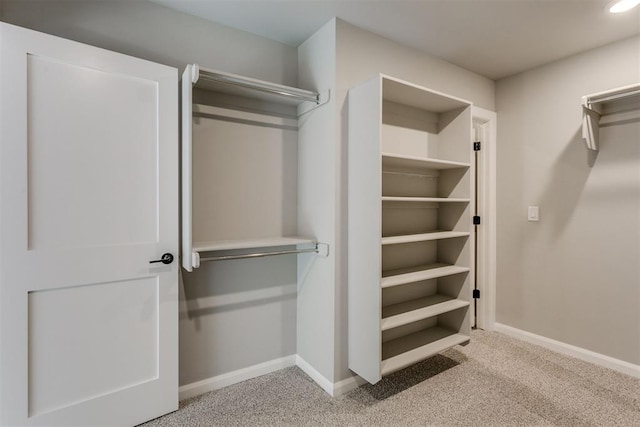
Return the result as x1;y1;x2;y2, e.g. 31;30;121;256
0;23;178;426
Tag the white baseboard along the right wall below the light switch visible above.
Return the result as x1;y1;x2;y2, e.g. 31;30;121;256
495;323;640;378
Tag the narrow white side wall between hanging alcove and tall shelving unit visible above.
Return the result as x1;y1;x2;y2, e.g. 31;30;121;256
297;21;339;382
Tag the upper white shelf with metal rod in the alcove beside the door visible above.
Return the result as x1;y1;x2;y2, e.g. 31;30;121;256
186;64;329;115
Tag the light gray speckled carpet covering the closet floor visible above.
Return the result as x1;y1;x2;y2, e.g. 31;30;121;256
144;331;640;427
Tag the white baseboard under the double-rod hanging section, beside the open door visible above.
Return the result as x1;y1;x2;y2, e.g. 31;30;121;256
178;354;298;400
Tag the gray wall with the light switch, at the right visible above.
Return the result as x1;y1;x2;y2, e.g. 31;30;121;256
496;38;640;364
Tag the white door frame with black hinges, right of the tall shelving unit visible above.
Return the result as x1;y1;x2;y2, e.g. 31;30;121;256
471;106;497;331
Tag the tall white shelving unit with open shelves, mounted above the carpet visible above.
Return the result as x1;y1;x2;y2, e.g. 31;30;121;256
348;75;475;384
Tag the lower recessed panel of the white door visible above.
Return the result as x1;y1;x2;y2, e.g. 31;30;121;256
29;277;158;416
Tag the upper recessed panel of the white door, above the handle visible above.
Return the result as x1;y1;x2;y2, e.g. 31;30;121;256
27;55;158;250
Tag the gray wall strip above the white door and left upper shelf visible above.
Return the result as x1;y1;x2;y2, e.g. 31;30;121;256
0;0;297;86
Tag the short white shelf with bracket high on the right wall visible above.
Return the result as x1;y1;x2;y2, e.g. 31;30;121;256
582;83;640;151
